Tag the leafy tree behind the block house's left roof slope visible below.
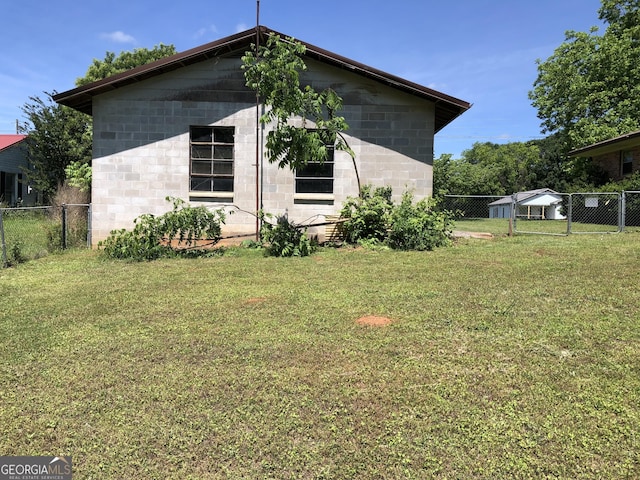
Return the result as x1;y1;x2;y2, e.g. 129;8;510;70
20;45;175;201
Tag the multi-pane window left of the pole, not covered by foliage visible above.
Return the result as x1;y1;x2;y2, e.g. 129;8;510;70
189;127;235;192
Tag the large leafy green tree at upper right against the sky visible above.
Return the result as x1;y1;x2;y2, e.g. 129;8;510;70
529;0;640;148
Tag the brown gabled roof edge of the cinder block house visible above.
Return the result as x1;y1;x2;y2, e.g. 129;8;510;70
53;26;471;132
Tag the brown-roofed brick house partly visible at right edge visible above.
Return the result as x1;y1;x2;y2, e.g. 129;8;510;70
569;130;640;180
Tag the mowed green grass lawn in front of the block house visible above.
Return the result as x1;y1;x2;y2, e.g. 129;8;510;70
0;234;640;479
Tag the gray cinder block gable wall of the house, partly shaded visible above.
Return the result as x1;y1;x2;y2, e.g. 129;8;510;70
92;55;435;242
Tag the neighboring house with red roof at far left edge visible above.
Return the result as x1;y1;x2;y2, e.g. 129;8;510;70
0;135;37;207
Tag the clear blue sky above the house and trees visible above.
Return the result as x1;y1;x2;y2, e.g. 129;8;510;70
0;0;601;158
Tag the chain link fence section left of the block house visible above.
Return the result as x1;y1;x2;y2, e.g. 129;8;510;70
0;204;91;267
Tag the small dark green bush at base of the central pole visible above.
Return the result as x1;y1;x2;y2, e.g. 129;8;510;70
260;214;317;257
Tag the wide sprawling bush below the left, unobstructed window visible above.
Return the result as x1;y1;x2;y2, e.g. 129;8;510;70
98;197;225;261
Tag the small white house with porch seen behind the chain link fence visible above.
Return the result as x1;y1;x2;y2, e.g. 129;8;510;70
489;188;566;220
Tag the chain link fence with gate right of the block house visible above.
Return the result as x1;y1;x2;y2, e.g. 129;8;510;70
441;191;640;235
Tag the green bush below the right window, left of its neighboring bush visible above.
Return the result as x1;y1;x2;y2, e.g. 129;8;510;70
340;185;393;244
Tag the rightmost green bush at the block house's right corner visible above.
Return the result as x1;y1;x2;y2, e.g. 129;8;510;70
388;192;453;250
